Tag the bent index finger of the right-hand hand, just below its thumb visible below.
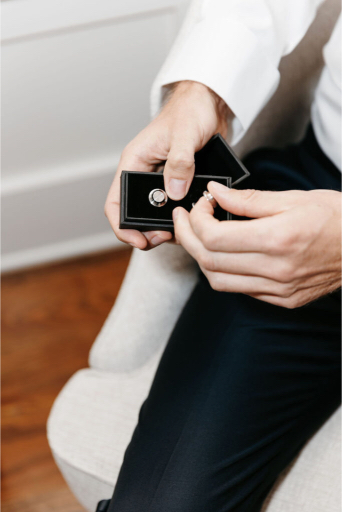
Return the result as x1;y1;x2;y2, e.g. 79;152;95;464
190;197;274;252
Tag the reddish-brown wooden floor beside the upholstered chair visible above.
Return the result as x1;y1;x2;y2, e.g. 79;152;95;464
2;250;130;512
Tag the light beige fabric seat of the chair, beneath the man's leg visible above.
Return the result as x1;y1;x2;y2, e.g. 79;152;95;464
48;352;341;512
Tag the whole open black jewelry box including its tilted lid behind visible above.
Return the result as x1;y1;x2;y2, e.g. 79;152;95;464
120;133;249;232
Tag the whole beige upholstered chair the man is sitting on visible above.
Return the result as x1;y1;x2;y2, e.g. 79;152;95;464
48;0;340;512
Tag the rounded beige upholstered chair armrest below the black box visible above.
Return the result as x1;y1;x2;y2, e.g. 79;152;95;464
89;244;198;372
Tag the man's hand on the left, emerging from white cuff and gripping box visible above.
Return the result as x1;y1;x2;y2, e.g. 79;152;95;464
105;81;232;249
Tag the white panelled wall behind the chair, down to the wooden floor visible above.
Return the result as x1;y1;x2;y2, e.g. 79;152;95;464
2;0;186;270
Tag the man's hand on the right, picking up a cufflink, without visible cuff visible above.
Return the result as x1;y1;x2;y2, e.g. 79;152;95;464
173;182;341;308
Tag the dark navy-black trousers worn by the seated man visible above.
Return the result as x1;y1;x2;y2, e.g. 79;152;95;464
109;128;341;512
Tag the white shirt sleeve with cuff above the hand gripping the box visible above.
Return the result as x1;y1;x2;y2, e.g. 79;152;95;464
151;0;323;144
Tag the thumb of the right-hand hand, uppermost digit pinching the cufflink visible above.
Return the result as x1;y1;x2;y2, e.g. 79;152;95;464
208;181;298;219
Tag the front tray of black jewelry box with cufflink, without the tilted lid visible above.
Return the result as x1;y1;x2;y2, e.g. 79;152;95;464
120;171;231;233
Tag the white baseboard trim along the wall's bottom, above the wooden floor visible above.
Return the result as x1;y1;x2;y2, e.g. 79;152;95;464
1;231;127;272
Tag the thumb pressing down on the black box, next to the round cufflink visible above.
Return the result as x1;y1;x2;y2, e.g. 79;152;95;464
164;140;195;201
